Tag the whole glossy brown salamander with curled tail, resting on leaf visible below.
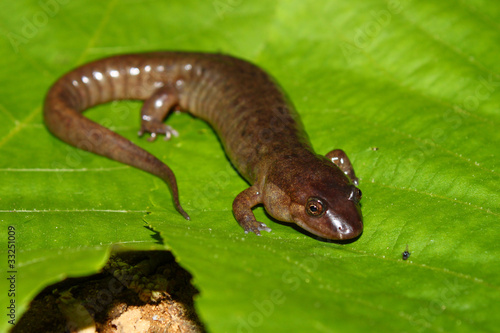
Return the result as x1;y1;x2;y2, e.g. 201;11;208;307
44;52;363;240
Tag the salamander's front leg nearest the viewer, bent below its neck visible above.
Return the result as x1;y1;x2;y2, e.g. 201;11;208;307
233;185;271;236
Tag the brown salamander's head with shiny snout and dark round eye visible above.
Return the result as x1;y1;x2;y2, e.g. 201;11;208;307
264;154;363;240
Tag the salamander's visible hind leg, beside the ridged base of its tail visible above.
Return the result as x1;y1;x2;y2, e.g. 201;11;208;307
139;87;179;141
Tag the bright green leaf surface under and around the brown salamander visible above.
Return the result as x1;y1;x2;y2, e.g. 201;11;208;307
0;0;500;332
